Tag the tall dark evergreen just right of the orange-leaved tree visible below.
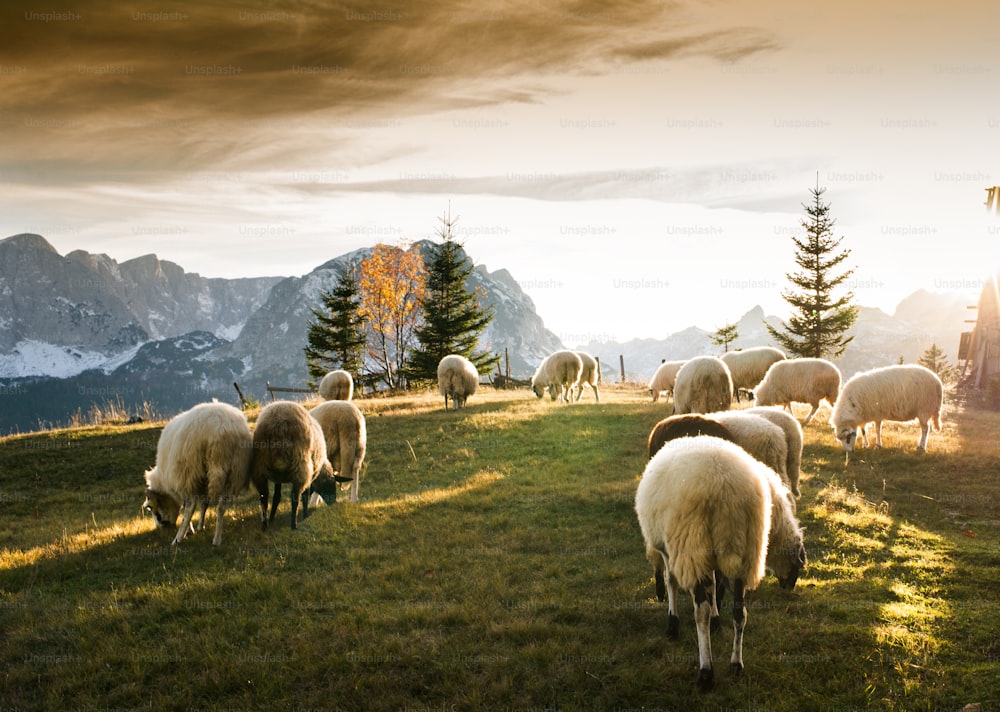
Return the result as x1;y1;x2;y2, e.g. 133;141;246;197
410;213;499;380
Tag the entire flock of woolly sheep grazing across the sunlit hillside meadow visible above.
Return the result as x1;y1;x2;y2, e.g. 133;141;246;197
137;347;943;689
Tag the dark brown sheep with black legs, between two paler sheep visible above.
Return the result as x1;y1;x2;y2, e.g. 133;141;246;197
250;401;333;531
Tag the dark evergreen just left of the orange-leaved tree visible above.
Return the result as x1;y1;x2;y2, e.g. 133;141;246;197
305;265;365;381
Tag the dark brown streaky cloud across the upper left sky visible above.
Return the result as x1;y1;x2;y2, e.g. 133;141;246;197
0;0;774;183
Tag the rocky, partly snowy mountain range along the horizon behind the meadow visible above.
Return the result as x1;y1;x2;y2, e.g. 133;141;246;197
0;234;969;435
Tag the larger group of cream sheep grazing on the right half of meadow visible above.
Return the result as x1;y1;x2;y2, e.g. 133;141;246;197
635;347;944;690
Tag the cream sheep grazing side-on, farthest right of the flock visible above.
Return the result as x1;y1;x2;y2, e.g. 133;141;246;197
830;364;944;464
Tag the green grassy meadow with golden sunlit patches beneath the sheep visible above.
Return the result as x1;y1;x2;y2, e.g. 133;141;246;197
0;386;1000;710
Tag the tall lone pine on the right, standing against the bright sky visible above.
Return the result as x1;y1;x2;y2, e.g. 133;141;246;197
766;185;858;358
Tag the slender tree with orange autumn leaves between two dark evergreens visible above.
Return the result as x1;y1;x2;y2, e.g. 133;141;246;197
357;245;426;388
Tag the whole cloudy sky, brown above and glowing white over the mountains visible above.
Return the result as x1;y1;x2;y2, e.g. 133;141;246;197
0;0;1000;345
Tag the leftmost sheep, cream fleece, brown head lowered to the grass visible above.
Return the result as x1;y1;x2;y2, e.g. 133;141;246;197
143;401;253;546
